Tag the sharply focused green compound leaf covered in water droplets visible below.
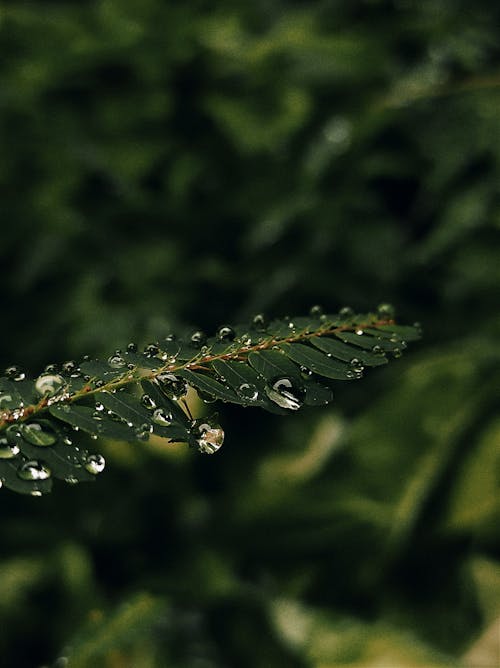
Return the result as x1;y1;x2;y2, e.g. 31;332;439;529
0;309;420;493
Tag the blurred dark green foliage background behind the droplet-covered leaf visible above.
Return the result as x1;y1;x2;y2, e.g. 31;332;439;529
0;0;500;668
